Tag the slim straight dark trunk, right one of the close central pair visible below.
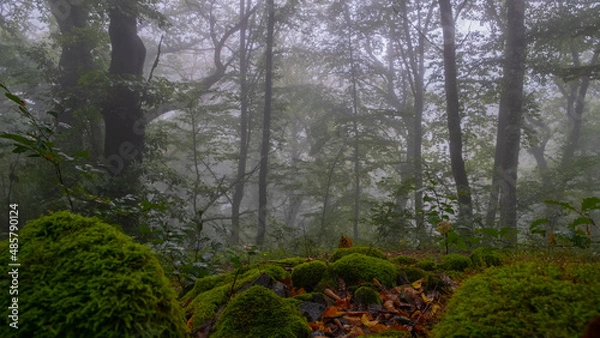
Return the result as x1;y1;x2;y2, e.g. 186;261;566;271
256;0;275;246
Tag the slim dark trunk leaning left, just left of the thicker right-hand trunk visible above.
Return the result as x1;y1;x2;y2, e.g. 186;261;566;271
439;0;473;233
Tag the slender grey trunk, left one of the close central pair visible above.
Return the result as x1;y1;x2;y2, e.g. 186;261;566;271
229;0;250;244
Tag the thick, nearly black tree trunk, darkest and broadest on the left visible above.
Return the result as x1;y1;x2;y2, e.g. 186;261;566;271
102;8;146;176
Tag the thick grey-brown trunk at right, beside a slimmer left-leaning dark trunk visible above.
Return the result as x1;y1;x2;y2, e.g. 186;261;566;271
495;0;527;243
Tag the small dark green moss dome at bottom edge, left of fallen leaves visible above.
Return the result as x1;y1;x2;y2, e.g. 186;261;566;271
211;286;310;338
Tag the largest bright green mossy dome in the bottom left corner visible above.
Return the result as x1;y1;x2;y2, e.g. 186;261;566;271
0;212;185;338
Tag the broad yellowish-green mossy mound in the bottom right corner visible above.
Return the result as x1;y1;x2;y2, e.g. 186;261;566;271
432;263;600;337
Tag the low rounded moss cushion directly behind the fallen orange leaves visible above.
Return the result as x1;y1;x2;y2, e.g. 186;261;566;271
332;253;397;287
